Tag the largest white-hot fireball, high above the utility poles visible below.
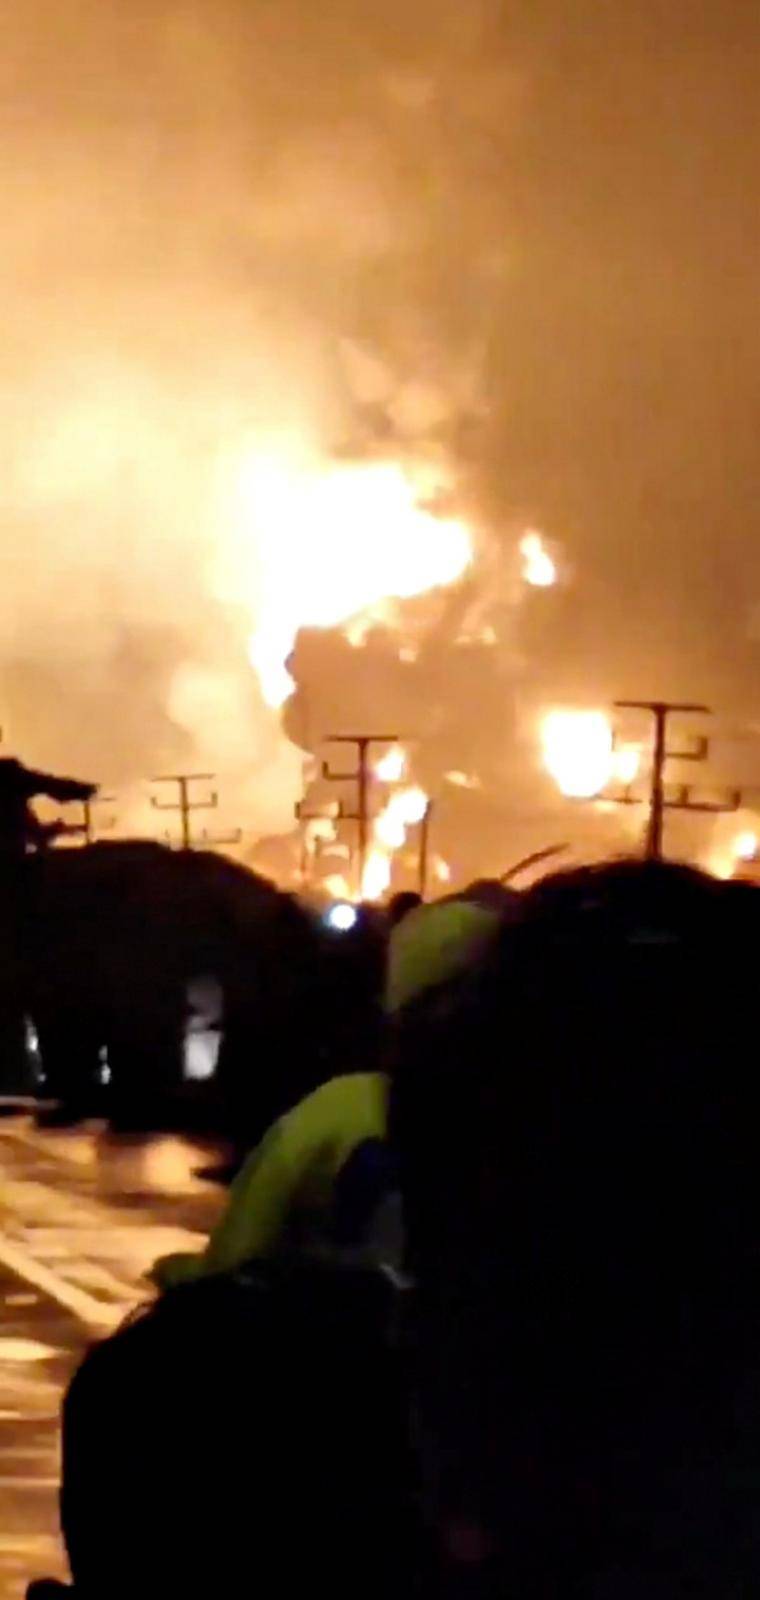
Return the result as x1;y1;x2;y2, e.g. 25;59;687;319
238;448;474;707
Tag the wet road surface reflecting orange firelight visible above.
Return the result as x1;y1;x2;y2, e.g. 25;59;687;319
0;1117;224;1600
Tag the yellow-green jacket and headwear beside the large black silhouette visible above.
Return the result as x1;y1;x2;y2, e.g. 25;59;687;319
152;899;501;1290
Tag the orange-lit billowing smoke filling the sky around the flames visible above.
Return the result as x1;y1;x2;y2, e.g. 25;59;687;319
0;0;760;876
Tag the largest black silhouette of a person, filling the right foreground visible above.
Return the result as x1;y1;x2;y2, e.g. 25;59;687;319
392;862;760;1594
